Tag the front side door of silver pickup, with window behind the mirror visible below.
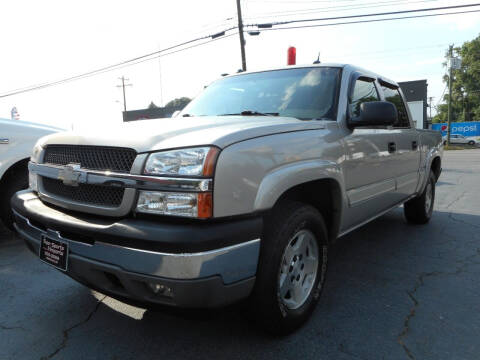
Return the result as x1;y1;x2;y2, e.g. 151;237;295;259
343;76;397;229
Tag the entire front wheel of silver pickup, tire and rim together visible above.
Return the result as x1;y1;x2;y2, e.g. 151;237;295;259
250;202;328;334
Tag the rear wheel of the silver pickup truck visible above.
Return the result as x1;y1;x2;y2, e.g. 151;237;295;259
403;171;437;224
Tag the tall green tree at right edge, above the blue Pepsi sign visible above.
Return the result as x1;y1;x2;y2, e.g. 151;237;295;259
433;35;480;122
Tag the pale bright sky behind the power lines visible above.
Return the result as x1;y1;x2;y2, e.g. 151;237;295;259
0;0;480;130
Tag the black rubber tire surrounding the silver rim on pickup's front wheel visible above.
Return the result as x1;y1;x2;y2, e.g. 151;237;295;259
249;201;328;335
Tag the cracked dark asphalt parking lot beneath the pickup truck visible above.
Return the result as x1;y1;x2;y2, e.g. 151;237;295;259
0;150;480;359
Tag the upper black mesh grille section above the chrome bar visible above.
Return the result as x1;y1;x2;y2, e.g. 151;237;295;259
43;145;137;173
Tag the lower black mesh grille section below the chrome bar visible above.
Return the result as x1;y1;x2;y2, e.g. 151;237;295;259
42;177;124;207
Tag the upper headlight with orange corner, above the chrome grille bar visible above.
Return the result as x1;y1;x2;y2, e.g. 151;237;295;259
144;147;219;176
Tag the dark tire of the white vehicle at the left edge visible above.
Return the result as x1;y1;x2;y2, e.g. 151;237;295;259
0;167;28;231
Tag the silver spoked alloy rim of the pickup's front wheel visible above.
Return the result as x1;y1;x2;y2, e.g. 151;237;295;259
278;229;319;309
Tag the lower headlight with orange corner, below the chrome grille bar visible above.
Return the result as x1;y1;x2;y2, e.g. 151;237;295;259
137;191;212;219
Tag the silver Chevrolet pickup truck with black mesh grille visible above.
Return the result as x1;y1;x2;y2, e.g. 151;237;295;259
12;64;443;333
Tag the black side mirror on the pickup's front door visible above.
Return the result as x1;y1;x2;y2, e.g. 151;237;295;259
349;101;398;127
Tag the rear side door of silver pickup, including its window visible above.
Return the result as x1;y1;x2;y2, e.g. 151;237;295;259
380;81;420;201
